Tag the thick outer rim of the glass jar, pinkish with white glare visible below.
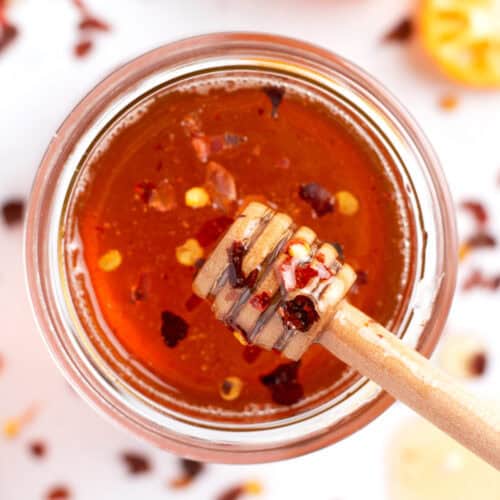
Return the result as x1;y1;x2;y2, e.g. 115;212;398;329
25;33;456;463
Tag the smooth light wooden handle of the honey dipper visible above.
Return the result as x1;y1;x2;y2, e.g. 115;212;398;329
319;301;500;470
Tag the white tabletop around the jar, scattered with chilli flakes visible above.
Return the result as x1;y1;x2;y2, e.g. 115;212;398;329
0;0;500;500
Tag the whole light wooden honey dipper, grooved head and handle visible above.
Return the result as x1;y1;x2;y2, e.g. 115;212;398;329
193;203;500;470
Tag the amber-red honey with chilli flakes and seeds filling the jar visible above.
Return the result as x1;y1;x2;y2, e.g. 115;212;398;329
65;80;413;419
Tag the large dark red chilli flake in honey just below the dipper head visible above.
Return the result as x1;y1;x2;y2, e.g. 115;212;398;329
260;361;304;405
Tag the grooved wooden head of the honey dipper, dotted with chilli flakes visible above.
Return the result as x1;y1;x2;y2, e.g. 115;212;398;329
193;202;356;360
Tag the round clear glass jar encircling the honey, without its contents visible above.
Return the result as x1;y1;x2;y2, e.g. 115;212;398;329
25;33;456;463
